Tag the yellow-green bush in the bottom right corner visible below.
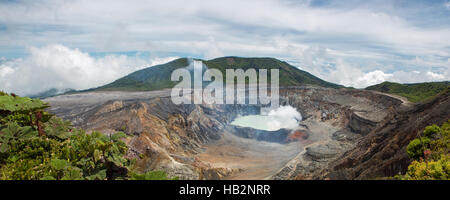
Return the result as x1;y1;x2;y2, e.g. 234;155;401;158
394;120;450;180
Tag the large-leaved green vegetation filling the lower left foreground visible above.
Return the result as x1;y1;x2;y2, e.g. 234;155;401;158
0;92;176;180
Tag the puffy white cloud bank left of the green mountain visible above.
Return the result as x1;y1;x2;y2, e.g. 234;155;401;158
0;45;178;95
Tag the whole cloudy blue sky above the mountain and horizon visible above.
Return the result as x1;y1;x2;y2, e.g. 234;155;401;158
0;0;450;94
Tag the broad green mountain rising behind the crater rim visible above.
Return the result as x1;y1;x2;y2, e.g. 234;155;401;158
91;57;342;91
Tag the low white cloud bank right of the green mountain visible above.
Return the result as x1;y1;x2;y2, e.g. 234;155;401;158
290;46;450;88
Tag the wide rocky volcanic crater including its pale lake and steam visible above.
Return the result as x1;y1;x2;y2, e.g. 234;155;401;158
45;86;401;179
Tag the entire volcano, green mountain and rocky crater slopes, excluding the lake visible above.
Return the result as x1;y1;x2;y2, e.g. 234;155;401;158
44;57;450;179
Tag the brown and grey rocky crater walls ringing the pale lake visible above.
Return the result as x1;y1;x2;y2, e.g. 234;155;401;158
45;86;401;179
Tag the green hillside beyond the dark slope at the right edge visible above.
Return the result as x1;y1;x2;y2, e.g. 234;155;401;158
366;81;450;102
